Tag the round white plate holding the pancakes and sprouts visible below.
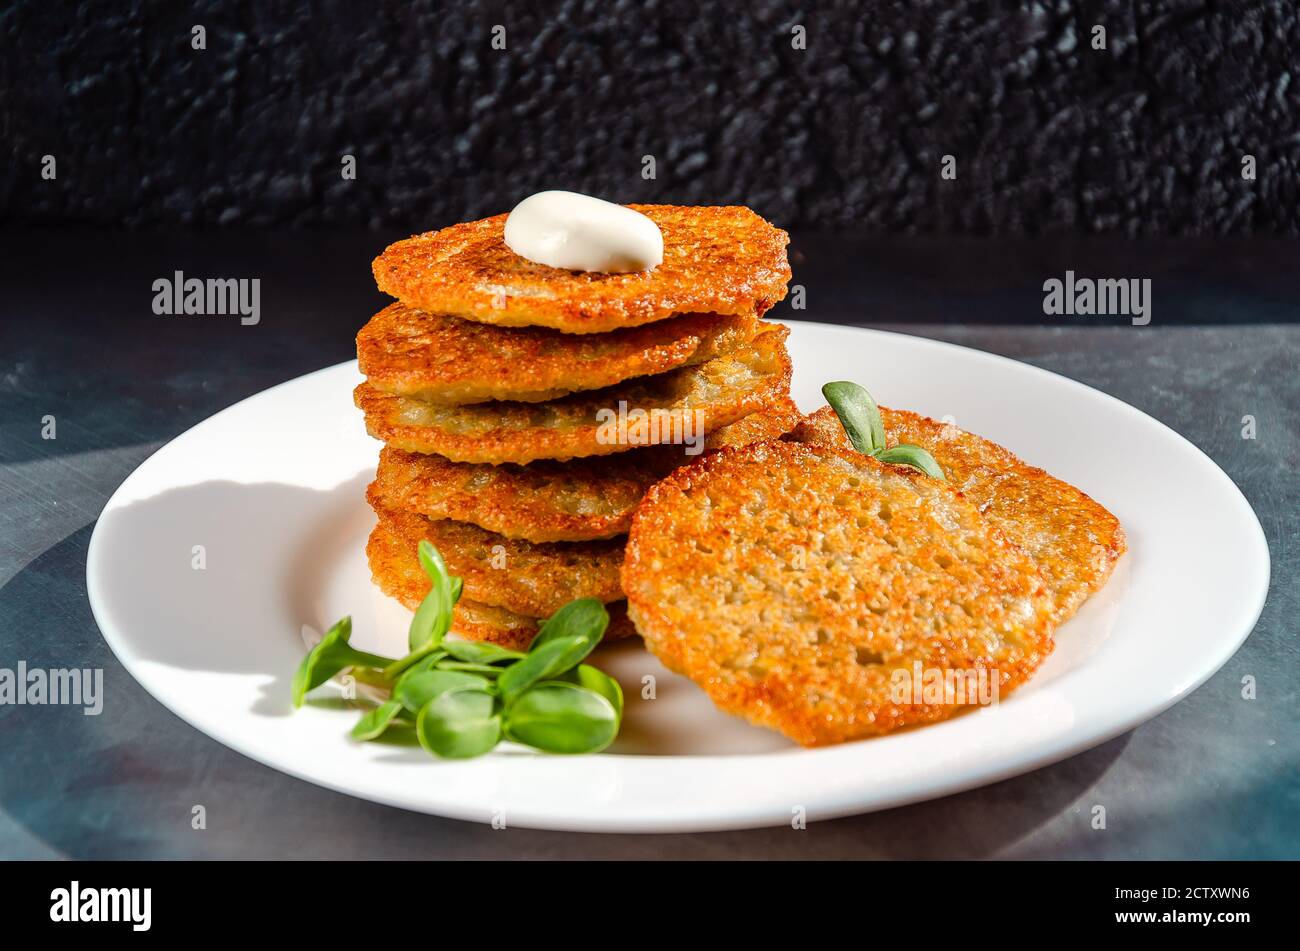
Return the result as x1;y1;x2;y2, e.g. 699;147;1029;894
86;323;1269;831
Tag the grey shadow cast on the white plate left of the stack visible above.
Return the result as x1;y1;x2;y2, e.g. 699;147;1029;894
96;472;371;691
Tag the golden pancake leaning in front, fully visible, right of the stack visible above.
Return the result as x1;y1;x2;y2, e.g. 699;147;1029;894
623;442;1052;746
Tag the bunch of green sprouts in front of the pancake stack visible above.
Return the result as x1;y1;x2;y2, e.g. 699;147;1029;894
294;542;623;759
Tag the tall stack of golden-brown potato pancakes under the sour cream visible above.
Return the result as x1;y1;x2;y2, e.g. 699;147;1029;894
355;205;798;646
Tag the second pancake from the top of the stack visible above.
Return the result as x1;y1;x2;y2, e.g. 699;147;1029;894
356;303;763;404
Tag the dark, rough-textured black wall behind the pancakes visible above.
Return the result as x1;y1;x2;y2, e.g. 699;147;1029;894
0;0;1300;235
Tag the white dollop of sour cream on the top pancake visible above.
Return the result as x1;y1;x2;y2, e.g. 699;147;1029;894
506;191;663;274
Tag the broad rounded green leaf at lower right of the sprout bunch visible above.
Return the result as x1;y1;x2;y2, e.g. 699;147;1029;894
506;681;619;754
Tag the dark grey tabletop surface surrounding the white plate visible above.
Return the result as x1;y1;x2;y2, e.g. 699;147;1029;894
0;234;1300;859
